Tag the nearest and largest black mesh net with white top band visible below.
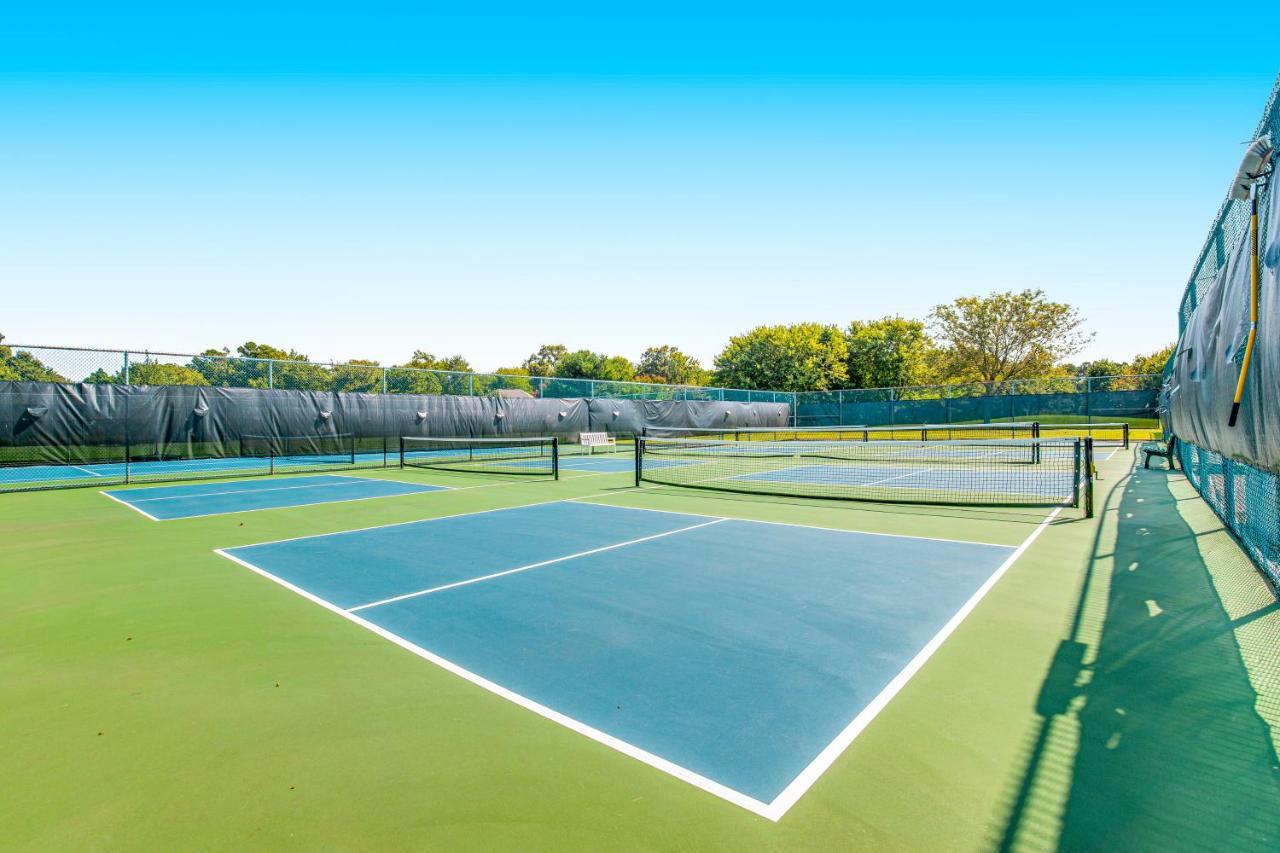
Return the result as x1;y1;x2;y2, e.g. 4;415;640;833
636;437;1093;515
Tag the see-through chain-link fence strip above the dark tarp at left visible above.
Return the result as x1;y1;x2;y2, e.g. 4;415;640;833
0;345;794;405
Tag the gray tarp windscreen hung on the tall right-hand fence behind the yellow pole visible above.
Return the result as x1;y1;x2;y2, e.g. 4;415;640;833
1166;166;1280;471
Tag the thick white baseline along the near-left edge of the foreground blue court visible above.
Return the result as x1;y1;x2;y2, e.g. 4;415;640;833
214;548;778;821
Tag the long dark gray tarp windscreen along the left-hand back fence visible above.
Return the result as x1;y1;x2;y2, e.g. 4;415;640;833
0;382;791;465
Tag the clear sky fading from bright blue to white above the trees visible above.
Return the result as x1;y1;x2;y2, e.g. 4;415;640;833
0;3;1277;369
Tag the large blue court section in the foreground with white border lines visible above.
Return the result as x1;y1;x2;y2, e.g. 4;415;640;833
221;502;1015;820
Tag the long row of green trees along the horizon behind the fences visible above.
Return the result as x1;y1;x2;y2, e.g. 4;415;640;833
0;289;1172;396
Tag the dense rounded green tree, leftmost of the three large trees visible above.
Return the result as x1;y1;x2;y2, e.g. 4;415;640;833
716;323;849;391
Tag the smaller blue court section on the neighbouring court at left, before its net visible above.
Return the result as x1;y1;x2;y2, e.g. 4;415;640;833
102;474;443;521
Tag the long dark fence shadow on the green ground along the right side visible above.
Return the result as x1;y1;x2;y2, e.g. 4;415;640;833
991;455;1280;850
